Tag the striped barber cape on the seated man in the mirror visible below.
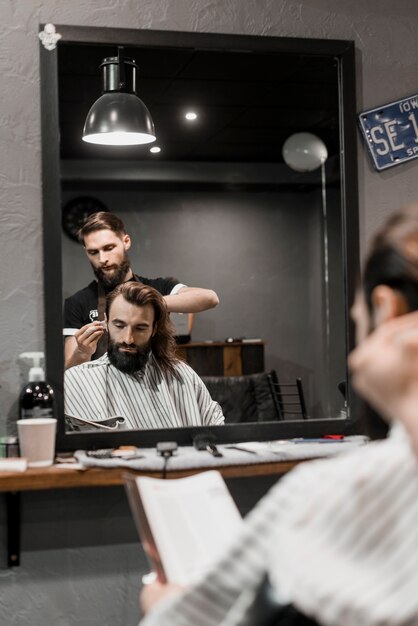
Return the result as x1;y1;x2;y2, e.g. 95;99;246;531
64;354;224;429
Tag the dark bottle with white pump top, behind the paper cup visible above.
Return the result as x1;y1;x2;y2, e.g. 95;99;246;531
19;352;54;419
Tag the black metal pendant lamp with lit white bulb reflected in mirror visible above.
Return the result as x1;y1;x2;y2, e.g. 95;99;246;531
83;46;155;146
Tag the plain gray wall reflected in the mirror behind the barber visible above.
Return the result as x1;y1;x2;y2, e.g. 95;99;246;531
62;188;345;417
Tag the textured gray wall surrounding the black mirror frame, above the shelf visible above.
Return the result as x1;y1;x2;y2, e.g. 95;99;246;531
4;0;418;424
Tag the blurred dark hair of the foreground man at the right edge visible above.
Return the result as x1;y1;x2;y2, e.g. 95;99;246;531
363;205;418;312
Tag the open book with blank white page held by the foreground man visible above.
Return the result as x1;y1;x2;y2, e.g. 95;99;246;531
124;471;243;585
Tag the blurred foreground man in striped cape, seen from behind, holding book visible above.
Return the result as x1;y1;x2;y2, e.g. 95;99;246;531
141;206;418;626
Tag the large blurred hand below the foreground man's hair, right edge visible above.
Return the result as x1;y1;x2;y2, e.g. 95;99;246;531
348;312;418;442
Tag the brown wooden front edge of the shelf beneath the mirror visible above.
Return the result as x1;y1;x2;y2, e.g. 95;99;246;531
0;461;298;492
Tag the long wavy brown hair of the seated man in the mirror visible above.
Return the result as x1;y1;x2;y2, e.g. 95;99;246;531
106;281;179;372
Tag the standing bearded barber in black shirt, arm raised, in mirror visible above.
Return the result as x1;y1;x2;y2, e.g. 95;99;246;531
64;211;219;369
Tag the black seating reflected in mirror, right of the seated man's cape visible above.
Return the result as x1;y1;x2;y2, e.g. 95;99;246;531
201;370;306;424
